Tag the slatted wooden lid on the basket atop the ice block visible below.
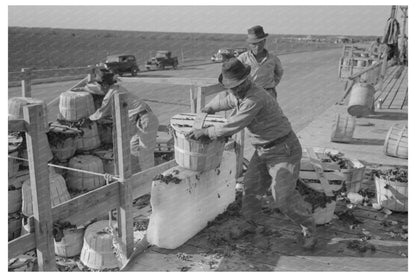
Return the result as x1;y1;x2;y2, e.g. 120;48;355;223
170;113;227;133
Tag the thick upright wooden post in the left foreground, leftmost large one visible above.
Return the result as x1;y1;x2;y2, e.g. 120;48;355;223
23;104;56;271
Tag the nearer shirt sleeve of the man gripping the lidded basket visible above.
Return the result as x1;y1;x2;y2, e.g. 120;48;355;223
208;99;262;139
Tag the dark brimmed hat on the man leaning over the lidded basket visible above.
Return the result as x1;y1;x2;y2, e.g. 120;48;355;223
218;58;251;88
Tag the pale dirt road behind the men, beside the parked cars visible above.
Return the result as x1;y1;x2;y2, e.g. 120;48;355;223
9;49;344;131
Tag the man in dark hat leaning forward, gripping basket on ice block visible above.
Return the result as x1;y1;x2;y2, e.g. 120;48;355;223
188;58;317;249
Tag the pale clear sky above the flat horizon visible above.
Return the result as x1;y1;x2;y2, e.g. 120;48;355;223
8;5;391;35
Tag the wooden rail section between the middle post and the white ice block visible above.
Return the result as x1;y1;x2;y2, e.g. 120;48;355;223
131;157;178;199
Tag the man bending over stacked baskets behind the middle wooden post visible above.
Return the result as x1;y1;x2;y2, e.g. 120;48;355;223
89;69;159;173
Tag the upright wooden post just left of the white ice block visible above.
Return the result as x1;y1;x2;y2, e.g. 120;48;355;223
113;93;134;262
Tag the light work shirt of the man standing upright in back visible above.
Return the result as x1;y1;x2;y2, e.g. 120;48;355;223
238;49;283;89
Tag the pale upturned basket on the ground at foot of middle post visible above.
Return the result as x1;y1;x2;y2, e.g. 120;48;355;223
80;220;121;270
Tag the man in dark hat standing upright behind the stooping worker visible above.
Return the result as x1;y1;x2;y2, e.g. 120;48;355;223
238;25;283;99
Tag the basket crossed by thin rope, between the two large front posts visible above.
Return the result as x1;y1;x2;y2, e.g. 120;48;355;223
67;155;105;191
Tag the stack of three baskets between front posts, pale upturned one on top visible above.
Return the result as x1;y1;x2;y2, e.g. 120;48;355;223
49;90;110;192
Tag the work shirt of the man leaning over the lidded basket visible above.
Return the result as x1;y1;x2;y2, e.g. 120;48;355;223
206;84;292;145
